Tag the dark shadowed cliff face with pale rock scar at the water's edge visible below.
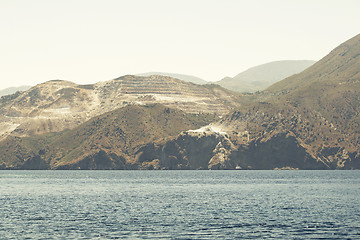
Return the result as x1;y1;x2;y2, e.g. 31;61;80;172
136;127;334;170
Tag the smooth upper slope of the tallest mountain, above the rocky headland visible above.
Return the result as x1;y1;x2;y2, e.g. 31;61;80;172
266;35;360;137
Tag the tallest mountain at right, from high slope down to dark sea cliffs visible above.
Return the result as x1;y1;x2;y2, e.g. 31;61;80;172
132;35;360;169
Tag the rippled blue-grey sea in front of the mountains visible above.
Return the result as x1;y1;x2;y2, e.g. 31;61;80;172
0;170;360;239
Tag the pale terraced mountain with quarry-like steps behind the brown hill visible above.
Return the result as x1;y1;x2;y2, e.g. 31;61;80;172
0;75;243;140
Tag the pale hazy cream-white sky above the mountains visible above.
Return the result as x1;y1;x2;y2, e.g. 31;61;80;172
0;0;360;89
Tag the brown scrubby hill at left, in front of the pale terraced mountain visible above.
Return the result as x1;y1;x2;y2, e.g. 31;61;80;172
0;104;218;169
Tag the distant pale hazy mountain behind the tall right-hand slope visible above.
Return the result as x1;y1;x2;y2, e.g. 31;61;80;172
216;60;315;92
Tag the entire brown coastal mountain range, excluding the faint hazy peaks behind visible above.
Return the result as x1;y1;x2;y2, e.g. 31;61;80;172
0;32;360;169
